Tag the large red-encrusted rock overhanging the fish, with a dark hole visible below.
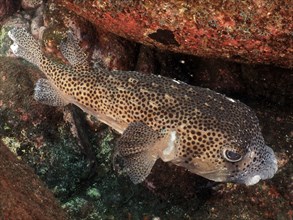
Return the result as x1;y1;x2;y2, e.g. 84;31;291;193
53;0;293;68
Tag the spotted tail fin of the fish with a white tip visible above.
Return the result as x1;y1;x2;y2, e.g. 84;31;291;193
8;28;43;66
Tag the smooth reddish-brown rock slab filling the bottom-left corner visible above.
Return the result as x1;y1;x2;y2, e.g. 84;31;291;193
0;140;67;220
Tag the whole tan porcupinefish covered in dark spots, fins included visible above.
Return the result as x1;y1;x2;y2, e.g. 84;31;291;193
9;28;277;185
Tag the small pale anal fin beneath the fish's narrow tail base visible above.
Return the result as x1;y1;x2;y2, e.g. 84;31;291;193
34;79;68;106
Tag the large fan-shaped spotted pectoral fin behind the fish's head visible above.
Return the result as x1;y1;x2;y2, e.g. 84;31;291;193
113;122;176;184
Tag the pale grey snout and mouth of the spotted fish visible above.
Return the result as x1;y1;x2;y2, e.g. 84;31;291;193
233;146;278;186
